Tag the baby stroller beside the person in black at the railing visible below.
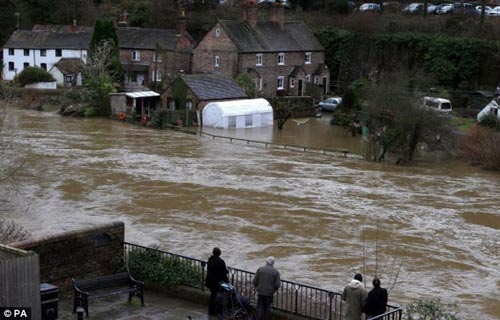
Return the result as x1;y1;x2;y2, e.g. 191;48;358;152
216;282;252;320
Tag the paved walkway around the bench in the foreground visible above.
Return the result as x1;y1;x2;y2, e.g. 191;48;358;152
59;290;208;320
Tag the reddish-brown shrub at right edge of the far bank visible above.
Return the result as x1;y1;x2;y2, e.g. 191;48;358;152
457;126;500;170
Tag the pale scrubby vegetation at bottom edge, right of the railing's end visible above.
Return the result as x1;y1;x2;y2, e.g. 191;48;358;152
403;299;460;320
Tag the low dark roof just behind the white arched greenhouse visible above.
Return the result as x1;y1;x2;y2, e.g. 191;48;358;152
182;74;247;101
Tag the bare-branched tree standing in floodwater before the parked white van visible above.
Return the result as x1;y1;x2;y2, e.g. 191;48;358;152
363;74;451;163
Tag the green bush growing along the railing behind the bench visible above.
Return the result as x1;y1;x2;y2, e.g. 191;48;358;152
128;250;203;287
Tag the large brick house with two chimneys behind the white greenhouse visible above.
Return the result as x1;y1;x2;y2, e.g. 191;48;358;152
193;0;330;96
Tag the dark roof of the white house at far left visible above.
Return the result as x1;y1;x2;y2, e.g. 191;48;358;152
4;25;92;50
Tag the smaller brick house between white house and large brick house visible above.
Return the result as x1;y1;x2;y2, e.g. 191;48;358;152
117;17;194;86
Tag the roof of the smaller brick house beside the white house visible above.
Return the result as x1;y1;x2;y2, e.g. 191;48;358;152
116;27;183;50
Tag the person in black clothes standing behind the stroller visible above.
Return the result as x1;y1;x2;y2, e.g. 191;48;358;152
205;247;229;315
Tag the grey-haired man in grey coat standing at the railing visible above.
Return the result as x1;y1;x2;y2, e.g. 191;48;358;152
253;257;281;320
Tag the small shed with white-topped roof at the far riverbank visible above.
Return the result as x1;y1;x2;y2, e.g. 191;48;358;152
110;91;161;124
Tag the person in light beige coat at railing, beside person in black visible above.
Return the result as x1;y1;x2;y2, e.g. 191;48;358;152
342;273;366;320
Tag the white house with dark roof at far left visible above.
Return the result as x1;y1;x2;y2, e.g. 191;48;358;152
2;25;92;80
